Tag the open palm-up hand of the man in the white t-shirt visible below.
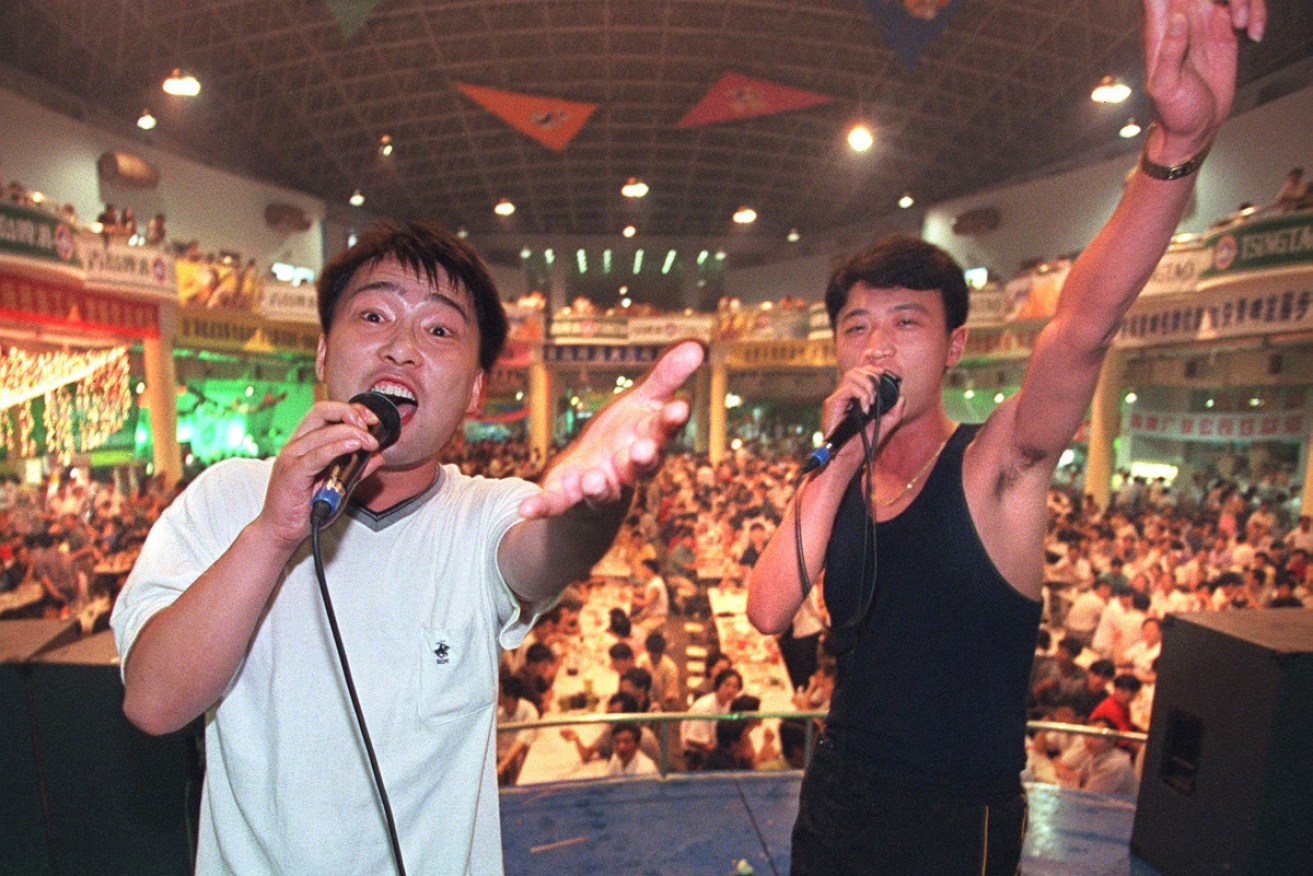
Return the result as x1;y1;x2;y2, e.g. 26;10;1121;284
520;341;704;519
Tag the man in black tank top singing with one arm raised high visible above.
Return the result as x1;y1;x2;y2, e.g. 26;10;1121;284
748;0;1266;876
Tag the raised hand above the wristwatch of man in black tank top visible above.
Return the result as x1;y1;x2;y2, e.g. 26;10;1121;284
1145;0;1267;150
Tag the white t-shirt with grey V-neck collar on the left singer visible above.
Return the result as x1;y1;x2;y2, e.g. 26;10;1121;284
112;460;546;876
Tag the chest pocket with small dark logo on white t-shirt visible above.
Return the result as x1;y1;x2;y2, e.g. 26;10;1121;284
416;623;496;725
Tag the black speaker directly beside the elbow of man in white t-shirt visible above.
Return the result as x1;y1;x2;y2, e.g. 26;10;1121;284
28;630;202;876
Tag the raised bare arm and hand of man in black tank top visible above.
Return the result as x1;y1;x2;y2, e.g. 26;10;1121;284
1006;0;1267;461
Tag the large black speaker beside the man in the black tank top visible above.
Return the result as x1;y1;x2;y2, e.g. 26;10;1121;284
1130;608;1313;876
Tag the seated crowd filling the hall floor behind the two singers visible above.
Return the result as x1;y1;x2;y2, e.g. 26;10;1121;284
0;441;1313;793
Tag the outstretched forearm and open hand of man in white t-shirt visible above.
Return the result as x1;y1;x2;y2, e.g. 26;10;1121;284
498;341;702;602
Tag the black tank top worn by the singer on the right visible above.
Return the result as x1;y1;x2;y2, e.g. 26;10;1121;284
825;424;1041;792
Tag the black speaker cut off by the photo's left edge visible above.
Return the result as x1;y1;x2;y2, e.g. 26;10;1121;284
0;620;81;876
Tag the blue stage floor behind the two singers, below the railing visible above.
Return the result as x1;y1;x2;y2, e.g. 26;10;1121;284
502;772;1158;876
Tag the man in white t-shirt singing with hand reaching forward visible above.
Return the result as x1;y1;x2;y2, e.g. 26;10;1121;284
112;222;702;876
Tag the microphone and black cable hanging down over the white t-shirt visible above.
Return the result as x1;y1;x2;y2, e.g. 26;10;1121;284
310;391;406;876
